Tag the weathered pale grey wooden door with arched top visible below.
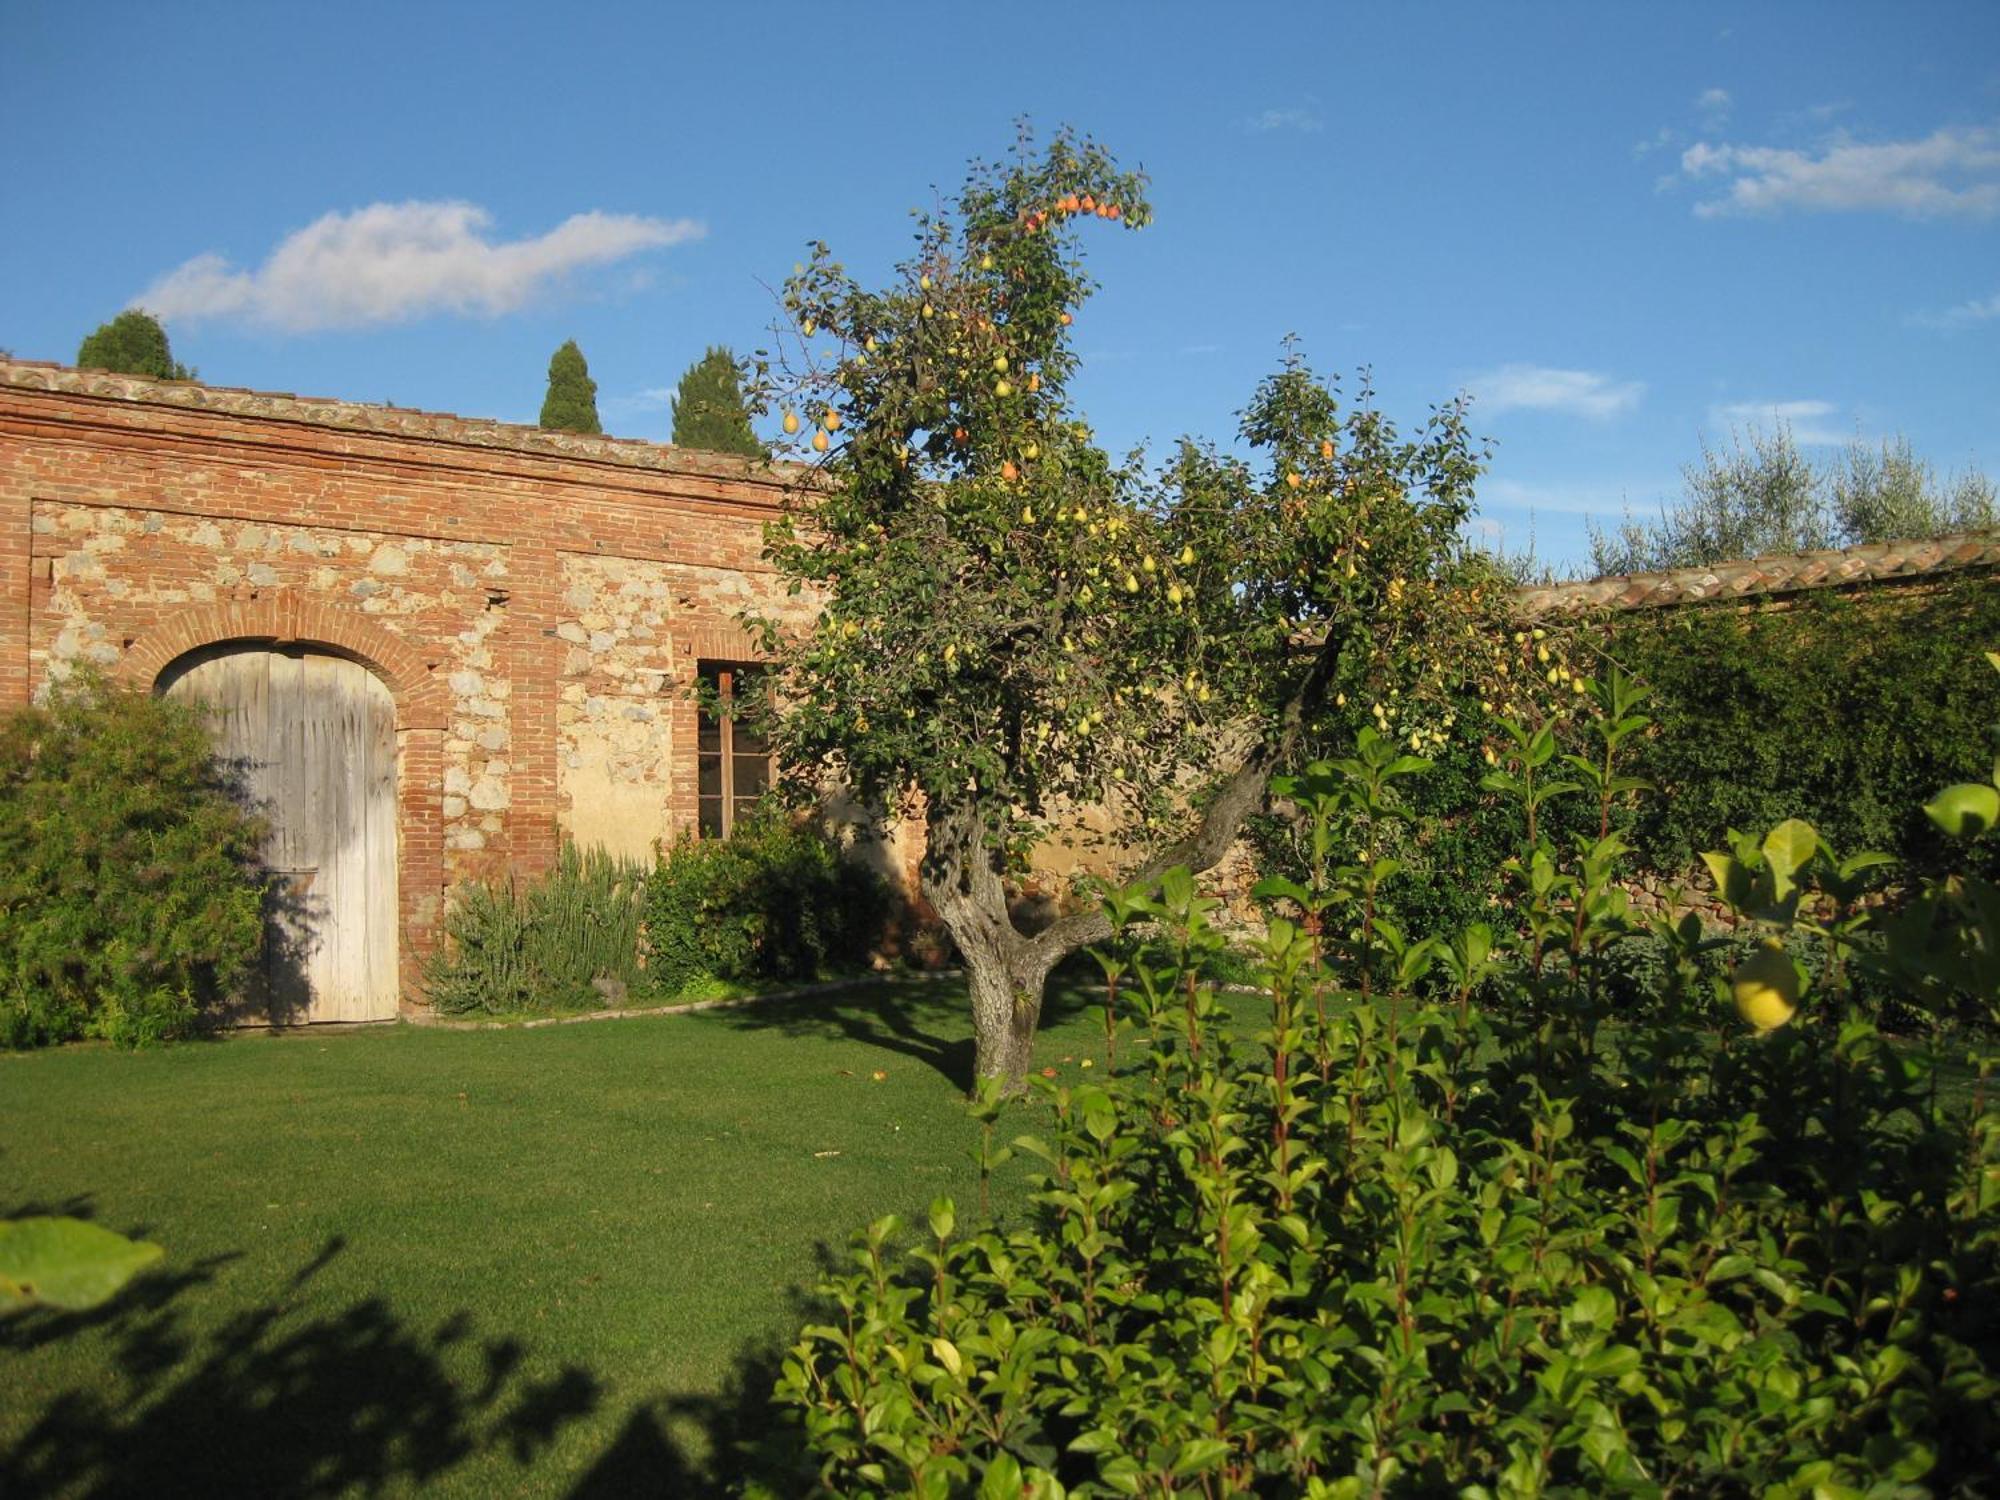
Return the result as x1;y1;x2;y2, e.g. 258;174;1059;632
160;644;398;1022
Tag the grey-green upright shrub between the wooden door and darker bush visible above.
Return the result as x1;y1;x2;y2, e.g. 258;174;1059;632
426;844;644;1016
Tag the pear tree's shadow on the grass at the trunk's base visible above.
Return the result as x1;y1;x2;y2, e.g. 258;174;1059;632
710;960;1090;1092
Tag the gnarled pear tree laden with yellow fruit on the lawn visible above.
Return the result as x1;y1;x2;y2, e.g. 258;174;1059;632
752;132;1490;1080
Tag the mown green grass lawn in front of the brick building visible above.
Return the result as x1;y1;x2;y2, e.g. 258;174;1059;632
0;982;1144;1500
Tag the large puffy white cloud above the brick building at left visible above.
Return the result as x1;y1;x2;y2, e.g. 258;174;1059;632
134;202;708;332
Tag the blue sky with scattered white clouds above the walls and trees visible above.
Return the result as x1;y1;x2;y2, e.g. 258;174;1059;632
0;0;2000;564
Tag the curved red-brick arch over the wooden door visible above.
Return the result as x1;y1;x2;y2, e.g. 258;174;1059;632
118;588;446;730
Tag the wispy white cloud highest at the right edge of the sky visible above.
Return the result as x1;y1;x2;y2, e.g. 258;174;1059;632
1680;128;2000;218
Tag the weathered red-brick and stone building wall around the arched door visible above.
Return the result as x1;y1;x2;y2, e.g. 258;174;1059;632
0;360;802;994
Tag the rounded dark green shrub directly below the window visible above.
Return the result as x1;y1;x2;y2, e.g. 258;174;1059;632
646;802;890;996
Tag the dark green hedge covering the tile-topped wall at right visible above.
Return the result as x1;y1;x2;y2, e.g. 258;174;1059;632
1248;574;2000;952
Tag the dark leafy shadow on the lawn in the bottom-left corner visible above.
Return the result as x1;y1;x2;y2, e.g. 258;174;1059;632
0;1236;602;1500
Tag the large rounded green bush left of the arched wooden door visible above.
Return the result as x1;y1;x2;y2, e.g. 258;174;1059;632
0;680;266;1046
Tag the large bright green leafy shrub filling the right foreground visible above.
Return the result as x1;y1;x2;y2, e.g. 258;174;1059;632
772;676;2000;1496
